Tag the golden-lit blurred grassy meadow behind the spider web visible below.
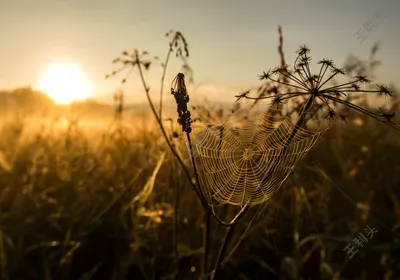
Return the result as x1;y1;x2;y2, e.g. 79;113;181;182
0;29;400;280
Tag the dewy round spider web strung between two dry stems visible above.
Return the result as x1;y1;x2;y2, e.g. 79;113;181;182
192;105;332;206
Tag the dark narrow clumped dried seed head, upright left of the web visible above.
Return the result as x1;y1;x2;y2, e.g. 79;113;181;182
171;73;192;133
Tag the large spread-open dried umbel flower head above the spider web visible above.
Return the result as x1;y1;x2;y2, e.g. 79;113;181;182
236;45;400;130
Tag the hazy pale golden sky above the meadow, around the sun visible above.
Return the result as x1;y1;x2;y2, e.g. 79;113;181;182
0;0;400;101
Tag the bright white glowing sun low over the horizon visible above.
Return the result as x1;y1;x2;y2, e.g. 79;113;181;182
38;62;92;104
